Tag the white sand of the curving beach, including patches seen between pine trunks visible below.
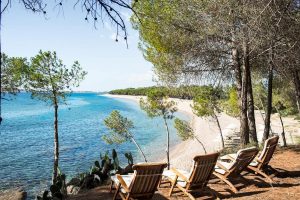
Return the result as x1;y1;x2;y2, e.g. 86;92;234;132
104;94;300;170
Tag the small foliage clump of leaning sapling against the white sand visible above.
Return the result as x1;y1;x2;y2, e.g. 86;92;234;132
174;118;195;141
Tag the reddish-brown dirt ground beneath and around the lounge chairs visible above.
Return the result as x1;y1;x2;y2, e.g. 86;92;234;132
69;146;300;200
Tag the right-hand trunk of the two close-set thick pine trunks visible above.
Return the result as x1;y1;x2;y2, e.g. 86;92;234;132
244;47;258;144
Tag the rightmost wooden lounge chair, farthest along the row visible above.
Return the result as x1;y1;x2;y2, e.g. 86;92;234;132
222;136;279;183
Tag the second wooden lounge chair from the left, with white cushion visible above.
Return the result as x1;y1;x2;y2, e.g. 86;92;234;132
163;153;219;200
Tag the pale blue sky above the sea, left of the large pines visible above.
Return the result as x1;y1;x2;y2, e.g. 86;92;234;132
1;1;155;91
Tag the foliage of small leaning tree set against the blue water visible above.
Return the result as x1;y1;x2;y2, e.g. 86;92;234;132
102;110;134;144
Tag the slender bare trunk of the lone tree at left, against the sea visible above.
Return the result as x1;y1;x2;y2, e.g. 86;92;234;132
52;103;59;184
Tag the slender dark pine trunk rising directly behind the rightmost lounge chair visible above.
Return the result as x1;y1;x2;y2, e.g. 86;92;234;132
263;48;274;142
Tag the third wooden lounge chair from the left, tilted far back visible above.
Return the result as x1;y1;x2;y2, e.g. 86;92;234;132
213;147;258;193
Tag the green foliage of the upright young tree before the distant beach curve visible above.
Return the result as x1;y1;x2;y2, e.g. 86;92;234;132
140;90;177;119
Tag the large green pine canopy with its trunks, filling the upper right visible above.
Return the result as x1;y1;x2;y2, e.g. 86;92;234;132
132;0;300;145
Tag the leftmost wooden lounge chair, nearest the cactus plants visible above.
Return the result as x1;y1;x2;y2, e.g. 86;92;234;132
111;163;167;200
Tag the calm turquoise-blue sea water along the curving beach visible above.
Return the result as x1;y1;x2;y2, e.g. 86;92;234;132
0;93;184;198
